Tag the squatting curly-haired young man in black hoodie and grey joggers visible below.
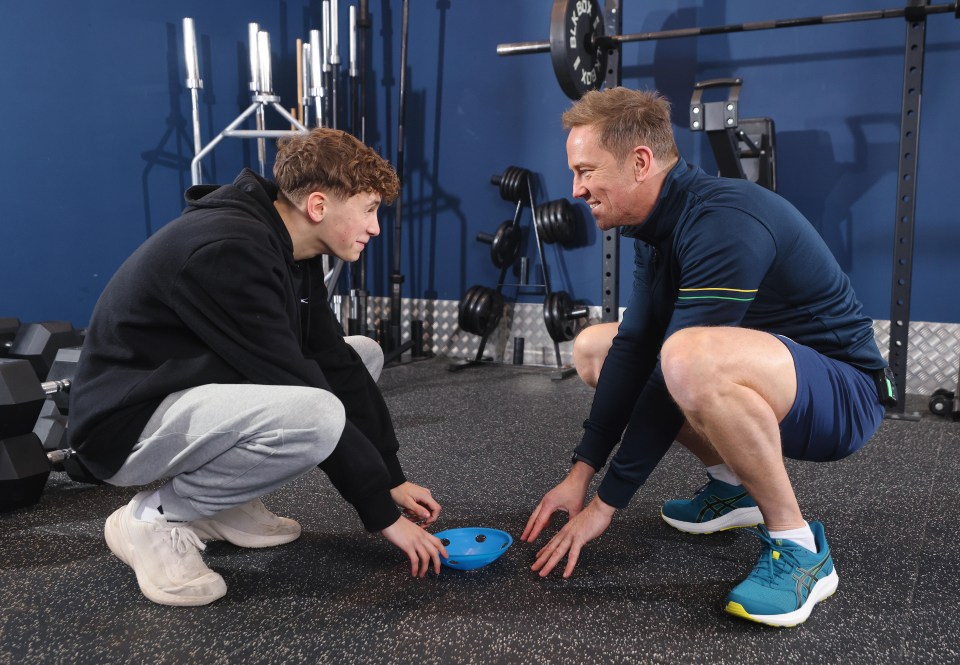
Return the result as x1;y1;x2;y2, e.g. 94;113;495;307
71;129;446;605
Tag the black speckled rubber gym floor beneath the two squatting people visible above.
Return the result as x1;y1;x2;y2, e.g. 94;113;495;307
0;358;960;665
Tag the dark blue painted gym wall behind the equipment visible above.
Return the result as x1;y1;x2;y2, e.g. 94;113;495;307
0;0;960;325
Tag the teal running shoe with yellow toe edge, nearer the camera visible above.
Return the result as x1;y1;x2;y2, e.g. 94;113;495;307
723;522;839;628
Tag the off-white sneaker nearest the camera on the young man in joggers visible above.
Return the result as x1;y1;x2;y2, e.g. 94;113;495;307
103;493;227;605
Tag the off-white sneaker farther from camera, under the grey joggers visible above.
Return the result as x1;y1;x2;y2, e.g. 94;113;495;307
190;499;300;547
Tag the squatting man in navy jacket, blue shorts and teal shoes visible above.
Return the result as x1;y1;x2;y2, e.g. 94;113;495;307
521;88;892;625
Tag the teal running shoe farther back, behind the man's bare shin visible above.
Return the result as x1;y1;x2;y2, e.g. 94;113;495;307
660;473;763;534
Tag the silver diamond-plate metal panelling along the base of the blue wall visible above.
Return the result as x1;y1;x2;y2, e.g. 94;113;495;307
356;298;960;395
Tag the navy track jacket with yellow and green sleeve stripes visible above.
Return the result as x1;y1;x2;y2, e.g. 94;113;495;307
575;158;886;508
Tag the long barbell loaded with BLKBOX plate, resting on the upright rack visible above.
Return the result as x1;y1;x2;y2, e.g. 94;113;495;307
497;0;960;99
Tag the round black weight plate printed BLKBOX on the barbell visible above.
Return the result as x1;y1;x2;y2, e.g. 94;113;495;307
550;0;607;99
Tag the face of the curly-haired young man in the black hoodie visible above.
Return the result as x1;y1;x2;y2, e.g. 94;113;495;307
317;192;380;262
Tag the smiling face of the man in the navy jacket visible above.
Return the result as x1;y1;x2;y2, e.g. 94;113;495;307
567;125;647;231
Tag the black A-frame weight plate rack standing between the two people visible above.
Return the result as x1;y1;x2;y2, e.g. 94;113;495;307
448;166;580;379
